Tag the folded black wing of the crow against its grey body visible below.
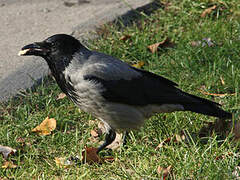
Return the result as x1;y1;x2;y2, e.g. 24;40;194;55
84;67;200;106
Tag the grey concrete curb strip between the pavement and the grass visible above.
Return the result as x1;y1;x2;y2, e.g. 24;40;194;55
0;0;160;101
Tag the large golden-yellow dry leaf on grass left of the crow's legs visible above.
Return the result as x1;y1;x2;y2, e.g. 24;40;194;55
32;117;56;136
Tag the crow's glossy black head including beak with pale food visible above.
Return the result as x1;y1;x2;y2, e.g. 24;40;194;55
18;34;82;60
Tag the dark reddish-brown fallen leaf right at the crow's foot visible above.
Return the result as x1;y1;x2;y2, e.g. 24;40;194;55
82;147;102;164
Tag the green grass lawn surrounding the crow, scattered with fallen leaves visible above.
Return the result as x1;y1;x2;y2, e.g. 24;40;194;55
0;0;240;179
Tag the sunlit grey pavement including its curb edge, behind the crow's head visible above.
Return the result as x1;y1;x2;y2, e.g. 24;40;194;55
0;0;153;101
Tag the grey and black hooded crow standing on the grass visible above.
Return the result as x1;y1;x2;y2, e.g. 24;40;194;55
19;34;232;152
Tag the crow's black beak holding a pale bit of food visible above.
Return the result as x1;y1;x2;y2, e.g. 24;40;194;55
18;42;49;56
